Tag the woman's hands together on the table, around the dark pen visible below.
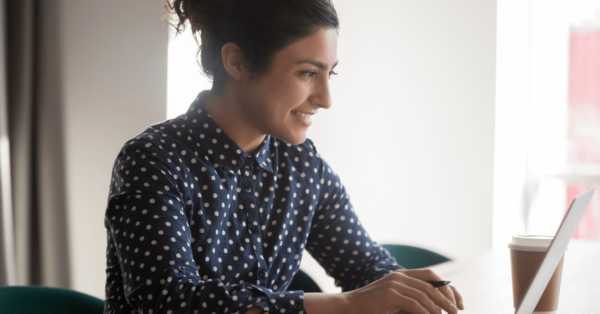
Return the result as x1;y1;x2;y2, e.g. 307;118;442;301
344;269;464;314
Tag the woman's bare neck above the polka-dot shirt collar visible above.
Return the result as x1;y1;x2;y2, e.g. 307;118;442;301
204;90;267;154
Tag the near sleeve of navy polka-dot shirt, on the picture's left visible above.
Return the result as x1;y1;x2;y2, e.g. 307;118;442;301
105;134;302;313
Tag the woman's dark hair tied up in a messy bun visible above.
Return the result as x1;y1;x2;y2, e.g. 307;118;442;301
164;0;339;93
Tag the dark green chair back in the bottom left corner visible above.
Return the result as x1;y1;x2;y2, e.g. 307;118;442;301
0;286;104;314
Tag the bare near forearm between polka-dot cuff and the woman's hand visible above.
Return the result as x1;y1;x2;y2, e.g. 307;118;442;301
246;292;352;314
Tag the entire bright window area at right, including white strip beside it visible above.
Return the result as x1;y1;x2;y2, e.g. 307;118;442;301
493;0;600;248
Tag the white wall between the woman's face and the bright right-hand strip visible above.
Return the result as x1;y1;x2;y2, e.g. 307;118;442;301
301;0;496;292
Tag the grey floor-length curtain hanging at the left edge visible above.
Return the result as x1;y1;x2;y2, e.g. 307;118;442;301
0;0;70;288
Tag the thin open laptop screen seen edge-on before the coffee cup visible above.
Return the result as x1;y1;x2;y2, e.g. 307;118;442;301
515;188;595;314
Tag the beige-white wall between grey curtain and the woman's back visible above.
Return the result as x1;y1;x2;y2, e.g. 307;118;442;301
58;0;167;299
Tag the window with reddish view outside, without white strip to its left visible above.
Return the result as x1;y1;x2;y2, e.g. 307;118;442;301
525;1;600;240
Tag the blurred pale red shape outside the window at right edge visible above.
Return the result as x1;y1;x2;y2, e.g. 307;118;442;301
567;29;600;240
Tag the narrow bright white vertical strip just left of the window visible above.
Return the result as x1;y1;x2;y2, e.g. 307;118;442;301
493;0;530;248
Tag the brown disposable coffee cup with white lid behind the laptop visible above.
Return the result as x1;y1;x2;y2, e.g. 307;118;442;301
508;235;565;314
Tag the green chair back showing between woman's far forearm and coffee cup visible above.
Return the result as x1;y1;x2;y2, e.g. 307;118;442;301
381;244;450;269
